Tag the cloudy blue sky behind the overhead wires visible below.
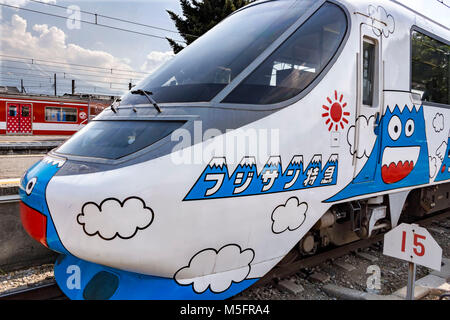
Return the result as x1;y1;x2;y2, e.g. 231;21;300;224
0;0;181;94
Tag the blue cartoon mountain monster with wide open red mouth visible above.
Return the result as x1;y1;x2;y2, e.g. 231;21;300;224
325;105;429;202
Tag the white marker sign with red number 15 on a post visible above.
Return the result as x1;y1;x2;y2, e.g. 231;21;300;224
383;223;442;300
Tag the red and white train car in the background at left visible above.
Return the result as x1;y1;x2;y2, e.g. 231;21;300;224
0;93;112;135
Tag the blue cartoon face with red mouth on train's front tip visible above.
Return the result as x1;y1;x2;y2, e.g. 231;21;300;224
19;156;67;253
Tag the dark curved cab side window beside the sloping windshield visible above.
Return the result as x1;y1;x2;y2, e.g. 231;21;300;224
223;3;347;104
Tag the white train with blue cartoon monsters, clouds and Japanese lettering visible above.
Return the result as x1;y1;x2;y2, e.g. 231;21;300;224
20;0;450;300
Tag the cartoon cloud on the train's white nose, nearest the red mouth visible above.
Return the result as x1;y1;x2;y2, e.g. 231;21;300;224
77;197;154;240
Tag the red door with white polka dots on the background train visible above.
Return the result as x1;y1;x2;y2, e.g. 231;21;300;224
6;103;32;134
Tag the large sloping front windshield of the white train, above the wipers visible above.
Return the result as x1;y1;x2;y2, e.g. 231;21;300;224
122;0;315;104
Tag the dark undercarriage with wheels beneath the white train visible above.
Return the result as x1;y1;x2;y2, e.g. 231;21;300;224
280;183;450;265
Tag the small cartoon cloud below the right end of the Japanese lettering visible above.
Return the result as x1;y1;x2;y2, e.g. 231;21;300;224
272;197;308;233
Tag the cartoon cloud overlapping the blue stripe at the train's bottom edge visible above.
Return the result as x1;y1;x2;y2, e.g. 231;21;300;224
174;244;255;293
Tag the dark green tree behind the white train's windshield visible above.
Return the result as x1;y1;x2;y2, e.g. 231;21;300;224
166;0;254;54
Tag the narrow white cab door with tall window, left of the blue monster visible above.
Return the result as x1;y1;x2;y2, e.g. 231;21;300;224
353;24;383;183
